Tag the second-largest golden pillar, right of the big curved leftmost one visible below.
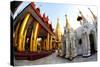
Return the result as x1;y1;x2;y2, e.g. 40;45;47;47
30;22;39;52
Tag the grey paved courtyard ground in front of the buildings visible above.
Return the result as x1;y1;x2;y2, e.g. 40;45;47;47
14;53;97;66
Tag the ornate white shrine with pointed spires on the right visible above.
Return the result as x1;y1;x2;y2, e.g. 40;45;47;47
60;9;97;60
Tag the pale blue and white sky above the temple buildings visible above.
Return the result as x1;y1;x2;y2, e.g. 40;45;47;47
14;2;97;33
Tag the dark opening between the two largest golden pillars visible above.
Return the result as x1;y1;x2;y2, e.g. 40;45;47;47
25;22;34;52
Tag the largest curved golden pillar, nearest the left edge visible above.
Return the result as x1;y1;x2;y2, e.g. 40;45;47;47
18;14;30;51
